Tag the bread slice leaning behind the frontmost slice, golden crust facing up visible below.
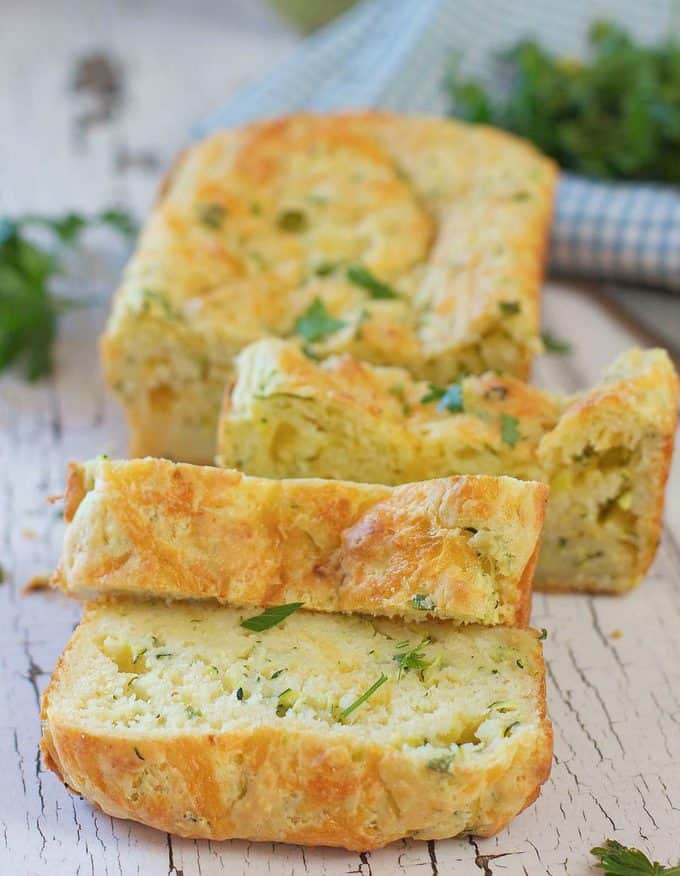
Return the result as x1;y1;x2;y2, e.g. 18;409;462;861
55;459;548;625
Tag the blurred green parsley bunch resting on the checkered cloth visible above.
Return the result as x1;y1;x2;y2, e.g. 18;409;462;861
448;21;680;183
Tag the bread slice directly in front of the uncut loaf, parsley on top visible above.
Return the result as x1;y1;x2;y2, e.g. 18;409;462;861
218;340;678;592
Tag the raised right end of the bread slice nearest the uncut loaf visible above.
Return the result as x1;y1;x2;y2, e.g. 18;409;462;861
535;349;678;593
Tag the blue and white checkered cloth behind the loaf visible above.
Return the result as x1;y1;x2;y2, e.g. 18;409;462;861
196;0;680;291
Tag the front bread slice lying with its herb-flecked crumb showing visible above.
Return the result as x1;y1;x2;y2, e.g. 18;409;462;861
41;598;552;850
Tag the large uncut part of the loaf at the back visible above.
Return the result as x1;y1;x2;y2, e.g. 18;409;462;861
102;112;556;463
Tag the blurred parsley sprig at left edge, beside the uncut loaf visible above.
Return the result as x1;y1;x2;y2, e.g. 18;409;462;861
0;210;136;381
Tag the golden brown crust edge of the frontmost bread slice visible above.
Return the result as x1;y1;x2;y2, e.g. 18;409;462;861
41;603;552;850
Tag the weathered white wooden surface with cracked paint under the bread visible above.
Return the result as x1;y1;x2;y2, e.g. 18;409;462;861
0;0;680;876
